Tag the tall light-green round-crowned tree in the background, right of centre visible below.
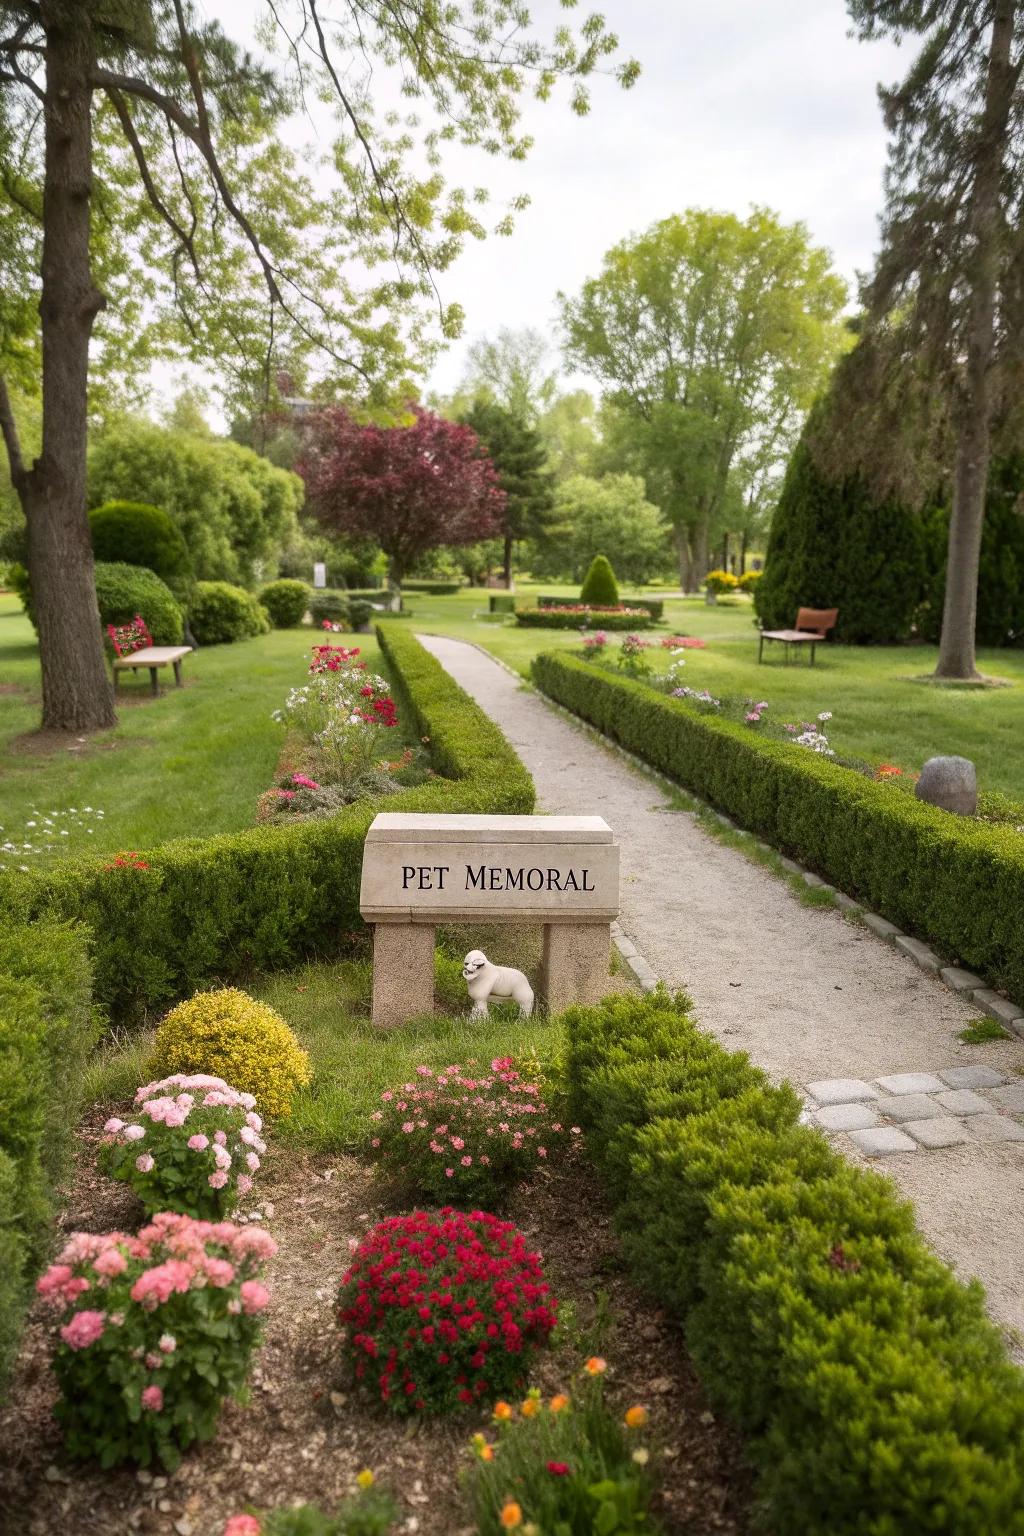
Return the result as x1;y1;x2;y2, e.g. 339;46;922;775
562;209;846;591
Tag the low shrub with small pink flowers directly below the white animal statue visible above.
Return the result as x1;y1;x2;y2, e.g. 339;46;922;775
368;1057;580;1204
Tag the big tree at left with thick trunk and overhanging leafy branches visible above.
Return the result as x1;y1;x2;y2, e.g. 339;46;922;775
0;0;637;730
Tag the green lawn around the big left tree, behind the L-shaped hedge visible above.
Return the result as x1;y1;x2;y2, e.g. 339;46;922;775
0;596;381;860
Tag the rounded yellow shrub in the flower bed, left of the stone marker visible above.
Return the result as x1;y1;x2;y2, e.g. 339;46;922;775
150;986;310;1115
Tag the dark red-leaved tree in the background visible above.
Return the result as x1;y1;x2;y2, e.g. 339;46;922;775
298;406;505;587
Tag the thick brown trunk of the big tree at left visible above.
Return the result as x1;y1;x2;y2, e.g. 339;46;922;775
21;0;115;731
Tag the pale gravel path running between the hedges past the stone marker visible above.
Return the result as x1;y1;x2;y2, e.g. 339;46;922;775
419;634;1024;1333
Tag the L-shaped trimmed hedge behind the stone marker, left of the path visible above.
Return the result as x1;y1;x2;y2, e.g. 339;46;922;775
0;625;534;1021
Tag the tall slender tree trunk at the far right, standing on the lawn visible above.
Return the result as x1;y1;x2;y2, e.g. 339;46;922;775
935;0;1016;680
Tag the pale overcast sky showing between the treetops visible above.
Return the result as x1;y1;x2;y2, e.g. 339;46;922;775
176;0;900;417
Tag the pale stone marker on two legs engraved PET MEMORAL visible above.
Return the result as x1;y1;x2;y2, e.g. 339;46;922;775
359;811;619;1026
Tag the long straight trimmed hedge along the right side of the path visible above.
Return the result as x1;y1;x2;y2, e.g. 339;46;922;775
533;653;1024;997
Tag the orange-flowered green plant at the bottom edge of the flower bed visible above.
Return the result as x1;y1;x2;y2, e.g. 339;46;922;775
467;1356;654;1536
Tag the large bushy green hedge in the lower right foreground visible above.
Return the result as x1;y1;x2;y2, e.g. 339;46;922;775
563;994;1024;1536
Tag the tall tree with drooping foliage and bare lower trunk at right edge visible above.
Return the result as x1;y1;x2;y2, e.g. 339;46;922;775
847;0;1024;679
